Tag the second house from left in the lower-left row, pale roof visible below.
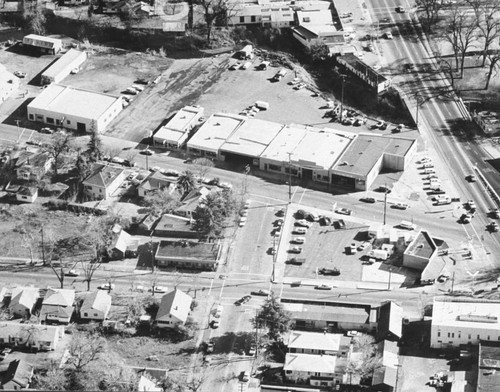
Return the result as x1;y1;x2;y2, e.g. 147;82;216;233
40;289;75;324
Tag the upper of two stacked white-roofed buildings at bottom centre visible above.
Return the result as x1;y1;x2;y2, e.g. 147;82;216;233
286;331;351;357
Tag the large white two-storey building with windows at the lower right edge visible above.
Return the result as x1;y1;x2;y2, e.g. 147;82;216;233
430;297;500;348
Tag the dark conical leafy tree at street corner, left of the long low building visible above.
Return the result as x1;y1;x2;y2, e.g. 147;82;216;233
252;293;291;341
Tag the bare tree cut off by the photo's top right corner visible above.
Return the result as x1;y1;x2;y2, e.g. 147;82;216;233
467;0;500;67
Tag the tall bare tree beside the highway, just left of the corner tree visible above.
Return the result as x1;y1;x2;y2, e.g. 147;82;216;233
443;5;477;77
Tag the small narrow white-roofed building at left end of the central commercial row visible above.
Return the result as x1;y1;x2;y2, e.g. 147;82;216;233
153;106;204;150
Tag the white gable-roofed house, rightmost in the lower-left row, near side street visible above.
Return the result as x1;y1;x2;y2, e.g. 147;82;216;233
156;289;193;329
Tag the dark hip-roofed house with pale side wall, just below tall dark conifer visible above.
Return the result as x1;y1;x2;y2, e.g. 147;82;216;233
82;164;125;200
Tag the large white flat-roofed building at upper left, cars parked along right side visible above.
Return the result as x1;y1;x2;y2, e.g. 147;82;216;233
28;84;123;133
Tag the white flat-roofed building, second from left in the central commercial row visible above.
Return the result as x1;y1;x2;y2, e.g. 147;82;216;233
187;113;245;158
